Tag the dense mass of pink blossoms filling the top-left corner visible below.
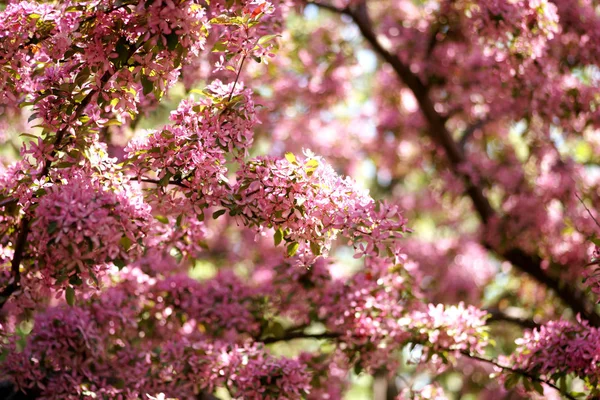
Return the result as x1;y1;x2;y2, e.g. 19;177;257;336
0;0;208;130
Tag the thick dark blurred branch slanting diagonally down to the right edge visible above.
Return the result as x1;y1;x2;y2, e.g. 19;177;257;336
307;0;600;326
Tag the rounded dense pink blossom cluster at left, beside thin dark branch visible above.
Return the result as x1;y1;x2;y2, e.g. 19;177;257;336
29;171;152;288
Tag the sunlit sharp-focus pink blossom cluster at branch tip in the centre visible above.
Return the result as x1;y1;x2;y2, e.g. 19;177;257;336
231;152;406;255
